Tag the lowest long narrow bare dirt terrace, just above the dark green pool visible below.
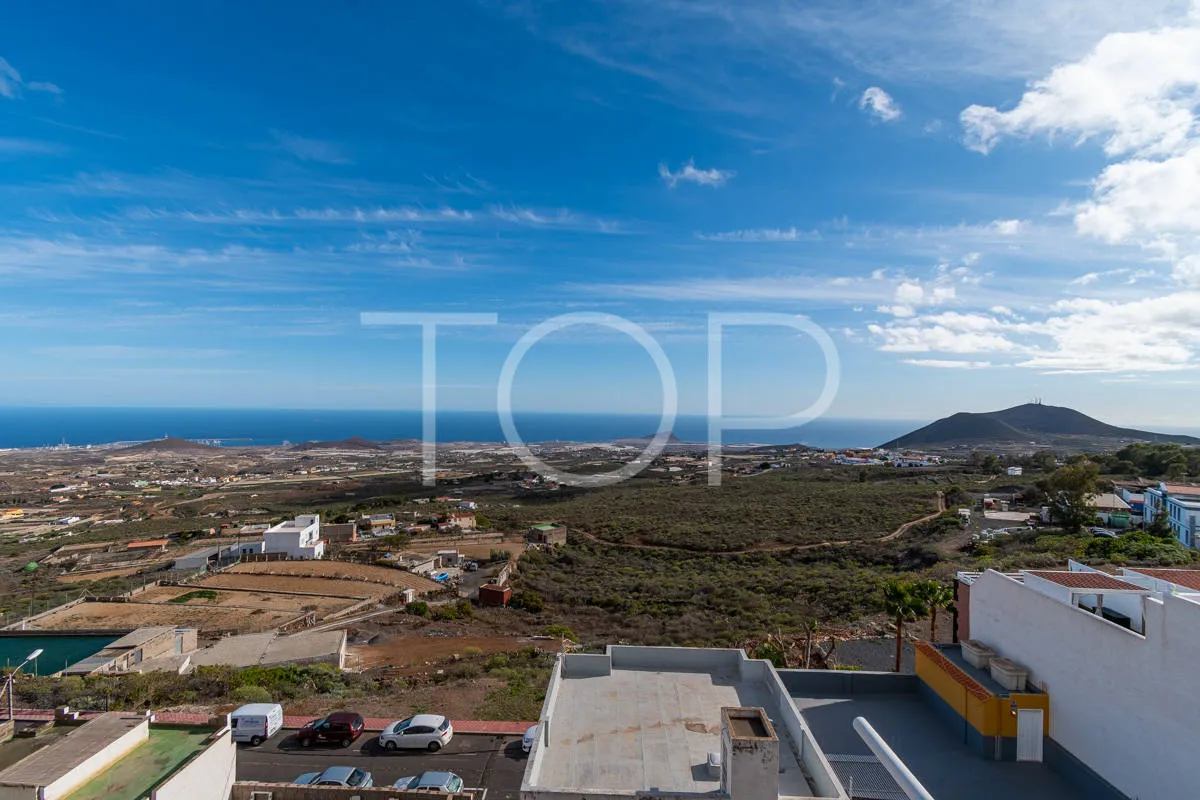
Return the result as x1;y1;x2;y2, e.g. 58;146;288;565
37;603;300;633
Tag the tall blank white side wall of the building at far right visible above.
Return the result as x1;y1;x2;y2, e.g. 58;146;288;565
971;570;1200;798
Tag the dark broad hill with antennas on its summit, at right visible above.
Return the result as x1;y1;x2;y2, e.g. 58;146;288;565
880;403;1200;451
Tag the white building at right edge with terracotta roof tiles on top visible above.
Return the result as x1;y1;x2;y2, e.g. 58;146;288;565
960;563;1200;798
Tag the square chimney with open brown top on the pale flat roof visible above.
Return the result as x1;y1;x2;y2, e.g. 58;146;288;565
721;706;779;800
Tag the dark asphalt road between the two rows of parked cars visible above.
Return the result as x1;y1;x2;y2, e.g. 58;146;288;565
238;730;526;800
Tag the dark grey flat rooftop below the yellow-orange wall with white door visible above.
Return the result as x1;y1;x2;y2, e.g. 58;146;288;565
792;692;1084;800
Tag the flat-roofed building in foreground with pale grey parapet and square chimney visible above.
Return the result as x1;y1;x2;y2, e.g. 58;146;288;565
521;645;846;800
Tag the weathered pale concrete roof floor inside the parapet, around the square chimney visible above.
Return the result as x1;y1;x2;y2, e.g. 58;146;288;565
536;664;814;798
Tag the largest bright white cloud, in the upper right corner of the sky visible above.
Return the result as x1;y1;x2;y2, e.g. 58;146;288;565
961;20;1200;248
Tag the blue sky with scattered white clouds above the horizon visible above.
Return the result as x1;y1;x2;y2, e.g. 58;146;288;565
0;0;1200;426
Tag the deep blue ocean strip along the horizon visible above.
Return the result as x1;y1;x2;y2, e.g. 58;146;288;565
0;407;928;449
